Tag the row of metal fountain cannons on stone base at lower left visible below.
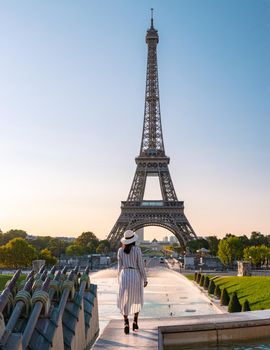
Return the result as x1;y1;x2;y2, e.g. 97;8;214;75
0;266;99;350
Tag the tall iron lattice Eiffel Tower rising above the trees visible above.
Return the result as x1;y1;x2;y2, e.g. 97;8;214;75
108;9;197;247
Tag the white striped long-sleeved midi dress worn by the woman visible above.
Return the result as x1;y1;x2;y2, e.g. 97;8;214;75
117;246;147;315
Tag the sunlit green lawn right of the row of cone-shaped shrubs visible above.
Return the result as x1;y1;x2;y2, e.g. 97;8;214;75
185;274;270;311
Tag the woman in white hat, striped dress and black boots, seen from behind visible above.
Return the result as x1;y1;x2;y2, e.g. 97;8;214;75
117;230;148;334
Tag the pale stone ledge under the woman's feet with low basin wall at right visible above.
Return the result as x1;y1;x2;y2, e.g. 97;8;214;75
93;310;270;350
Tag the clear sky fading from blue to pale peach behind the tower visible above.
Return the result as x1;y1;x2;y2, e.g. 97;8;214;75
0;0;270;238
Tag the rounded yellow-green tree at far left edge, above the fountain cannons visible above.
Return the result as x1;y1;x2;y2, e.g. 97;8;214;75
0;238;37;268
